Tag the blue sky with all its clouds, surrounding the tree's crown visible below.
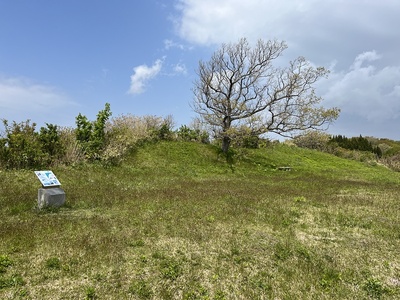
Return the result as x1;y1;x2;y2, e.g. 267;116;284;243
0;0;400;140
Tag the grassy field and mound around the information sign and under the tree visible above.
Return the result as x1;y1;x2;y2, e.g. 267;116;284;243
0;142;400;299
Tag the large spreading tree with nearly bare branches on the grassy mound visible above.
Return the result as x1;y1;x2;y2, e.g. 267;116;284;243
193;38;339;153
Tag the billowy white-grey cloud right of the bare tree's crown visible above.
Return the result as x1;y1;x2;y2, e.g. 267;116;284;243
318;51;400;123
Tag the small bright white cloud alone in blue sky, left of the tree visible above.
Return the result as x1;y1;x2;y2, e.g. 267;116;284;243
128;58;164;94
